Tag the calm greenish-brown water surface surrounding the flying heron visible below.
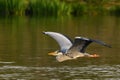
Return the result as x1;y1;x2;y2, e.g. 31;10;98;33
0;16;120;80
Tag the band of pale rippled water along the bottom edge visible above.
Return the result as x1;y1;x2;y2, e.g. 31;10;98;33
0;65;120;80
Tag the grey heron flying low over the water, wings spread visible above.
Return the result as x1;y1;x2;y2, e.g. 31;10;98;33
43;32;110;62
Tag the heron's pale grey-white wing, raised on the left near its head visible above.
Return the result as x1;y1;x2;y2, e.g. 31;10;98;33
43;32;72;51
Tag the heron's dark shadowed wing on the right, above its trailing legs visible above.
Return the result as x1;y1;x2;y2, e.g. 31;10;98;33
68;37;111;53
